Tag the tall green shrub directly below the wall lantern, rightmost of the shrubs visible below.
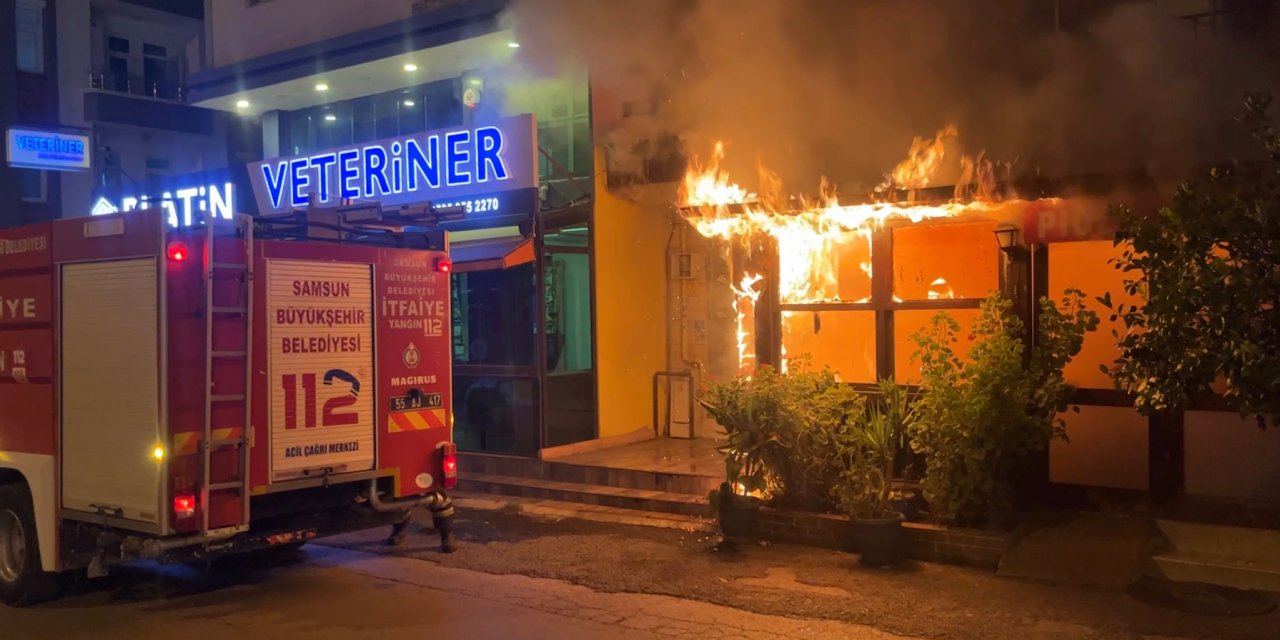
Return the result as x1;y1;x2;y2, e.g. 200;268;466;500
909;289;1098;524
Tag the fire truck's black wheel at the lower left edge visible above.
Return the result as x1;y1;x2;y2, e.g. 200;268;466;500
0;484;58;607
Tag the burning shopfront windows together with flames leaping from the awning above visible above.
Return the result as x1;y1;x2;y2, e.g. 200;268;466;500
680;128;1049;383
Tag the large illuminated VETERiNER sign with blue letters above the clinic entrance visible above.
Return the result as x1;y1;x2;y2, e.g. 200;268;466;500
248;114;538;215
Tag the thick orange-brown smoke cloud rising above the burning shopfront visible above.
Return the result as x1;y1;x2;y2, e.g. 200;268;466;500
511;0;1275;192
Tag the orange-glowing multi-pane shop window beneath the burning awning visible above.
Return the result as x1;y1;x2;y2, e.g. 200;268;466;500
768;221;1001;383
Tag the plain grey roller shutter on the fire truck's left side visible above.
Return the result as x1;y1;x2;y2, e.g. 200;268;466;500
59;257;164;524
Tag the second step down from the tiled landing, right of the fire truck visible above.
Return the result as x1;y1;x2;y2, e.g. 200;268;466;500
458;472;710;516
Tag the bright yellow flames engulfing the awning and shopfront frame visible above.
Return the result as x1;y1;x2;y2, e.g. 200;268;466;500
680;127;1039;375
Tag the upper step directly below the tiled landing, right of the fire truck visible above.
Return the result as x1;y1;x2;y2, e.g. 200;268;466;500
458;453;721;498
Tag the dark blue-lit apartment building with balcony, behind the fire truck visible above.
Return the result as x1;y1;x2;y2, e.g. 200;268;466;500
0;0;247;225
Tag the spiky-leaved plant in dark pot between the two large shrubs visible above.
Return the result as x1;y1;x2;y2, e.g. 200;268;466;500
832;380;915;566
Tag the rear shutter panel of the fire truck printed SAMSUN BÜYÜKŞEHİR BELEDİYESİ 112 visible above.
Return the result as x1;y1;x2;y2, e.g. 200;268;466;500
268;260;376;480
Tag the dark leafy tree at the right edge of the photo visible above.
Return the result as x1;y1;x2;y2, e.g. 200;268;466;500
1098;95;1280;426
